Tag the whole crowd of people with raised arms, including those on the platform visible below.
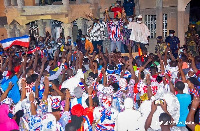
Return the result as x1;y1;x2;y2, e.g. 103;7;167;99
0;1;200;131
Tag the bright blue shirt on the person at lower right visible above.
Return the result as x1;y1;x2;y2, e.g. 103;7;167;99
176;94;191;127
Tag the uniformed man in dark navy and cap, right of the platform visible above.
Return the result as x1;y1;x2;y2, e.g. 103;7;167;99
165;30;180;58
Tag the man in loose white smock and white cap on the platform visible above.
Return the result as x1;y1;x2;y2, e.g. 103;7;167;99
128;15;150;51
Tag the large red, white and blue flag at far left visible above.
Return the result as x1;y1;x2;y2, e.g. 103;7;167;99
0;35;29;49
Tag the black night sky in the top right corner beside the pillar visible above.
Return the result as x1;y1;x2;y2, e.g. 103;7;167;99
190;0;200;22
